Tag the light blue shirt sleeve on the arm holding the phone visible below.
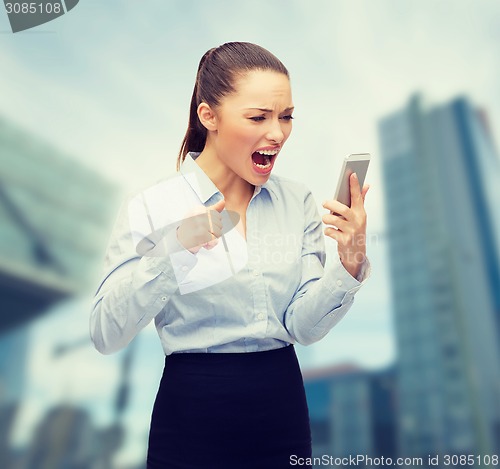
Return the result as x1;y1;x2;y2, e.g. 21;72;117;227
285;186;371;345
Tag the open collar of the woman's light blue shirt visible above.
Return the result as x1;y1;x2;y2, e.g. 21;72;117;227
180;151;278;203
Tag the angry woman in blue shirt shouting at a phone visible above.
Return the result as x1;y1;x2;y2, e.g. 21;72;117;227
91;42;369;469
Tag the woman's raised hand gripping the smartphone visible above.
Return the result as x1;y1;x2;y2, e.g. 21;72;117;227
322;173;370;278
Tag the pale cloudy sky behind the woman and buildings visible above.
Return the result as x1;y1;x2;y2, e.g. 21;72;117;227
0;0;500;459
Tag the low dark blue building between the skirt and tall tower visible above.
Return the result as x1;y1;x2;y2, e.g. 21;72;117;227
304;365;396;458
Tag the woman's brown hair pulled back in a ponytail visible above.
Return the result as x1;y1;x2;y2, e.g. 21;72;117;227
177;42;289;169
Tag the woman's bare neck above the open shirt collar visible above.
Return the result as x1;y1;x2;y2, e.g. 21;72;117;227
196;147;254;205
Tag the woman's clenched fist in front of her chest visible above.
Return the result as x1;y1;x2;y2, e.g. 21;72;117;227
177;199;226;254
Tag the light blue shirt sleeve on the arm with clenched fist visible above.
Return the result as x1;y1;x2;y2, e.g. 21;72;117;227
90;193;197;354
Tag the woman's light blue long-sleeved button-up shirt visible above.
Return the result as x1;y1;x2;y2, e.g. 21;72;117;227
90;153;370;355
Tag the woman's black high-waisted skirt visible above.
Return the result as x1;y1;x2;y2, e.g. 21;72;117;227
147;345;311;469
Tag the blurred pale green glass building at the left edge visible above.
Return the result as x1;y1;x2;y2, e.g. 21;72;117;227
0;118;118;467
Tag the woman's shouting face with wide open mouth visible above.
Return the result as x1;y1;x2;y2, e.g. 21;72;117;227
206;70;293;185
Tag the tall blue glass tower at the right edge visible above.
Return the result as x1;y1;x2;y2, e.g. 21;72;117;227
379;96;500;457
